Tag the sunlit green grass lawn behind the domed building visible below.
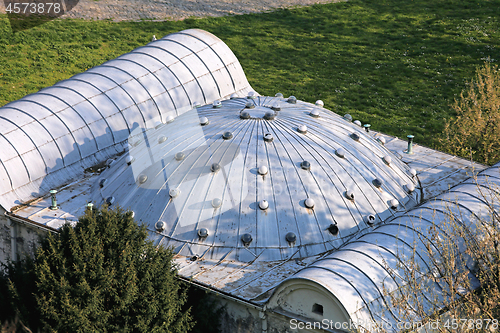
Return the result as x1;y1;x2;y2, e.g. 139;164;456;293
0;0;500;147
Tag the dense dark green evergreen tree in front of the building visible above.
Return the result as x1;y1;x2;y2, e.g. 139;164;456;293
0;208;193;332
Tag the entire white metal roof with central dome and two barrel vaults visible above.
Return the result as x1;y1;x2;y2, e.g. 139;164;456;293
0;30;492;321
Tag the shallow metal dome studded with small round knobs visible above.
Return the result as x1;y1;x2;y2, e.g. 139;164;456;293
93;95;418;262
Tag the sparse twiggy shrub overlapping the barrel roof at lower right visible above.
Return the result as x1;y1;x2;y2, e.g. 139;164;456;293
382;172;500;332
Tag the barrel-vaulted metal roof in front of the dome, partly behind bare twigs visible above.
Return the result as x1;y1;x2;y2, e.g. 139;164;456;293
270;163;500;331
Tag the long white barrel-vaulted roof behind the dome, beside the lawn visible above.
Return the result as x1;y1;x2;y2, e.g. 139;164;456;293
0;29;252;208
